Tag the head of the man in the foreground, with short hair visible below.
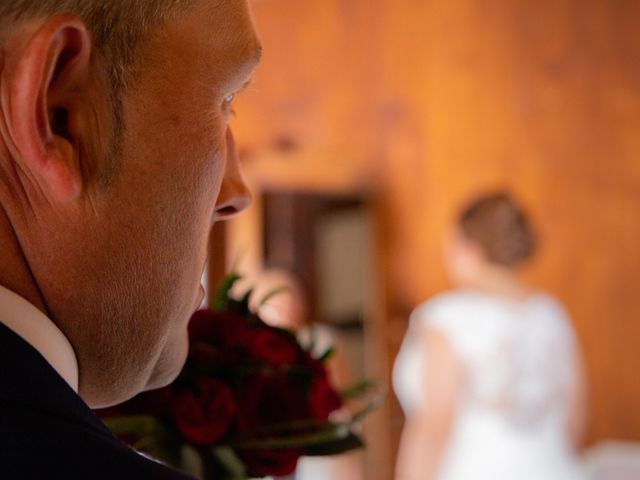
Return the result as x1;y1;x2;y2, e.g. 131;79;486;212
0;0;260;407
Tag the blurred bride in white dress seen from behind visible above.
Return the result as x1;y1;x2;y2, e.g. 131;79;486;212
394;194;586;480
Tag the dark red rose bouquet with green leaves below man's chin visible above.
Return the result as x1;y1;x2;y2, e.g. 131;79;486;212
101;275;379;480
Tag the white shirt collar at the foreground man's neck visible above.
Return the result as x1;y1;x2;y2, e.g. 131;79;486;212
0;285;78;393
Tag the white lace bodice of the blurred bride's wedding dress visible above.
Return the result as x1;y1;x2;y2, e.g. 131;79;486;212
394;290;576;430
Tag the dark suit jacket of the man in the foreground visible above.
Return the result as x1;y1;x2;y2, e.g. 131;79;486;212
0;323;191;480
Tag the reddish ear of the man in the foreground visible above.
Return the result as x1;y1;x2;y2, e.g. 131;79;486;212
2;14;91;203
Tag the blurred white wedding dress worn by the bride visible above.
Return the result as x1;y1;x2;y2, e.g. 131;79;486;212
394;289;584;480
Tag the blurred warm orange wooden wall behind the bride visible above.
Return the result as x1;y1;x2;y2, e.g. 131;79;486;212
234;0;640;454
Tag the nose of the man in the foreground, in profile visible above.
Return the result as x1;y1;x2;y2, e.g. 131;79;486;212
214;129;251;221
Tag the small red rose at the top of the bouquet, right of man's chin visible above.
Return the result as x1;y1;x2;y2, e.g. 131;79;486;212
251;325;302;367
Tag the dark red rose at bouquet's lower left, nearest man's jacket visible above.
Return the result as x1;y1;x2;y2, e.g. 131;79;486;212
174;378;236;446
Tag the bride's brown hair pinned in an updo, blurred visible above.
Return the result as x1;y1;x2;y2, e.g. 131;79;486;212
458;192;536;267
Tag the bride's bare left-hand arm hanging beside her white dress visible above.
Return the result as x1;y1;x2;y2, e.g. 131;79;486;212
395;329;463;480
